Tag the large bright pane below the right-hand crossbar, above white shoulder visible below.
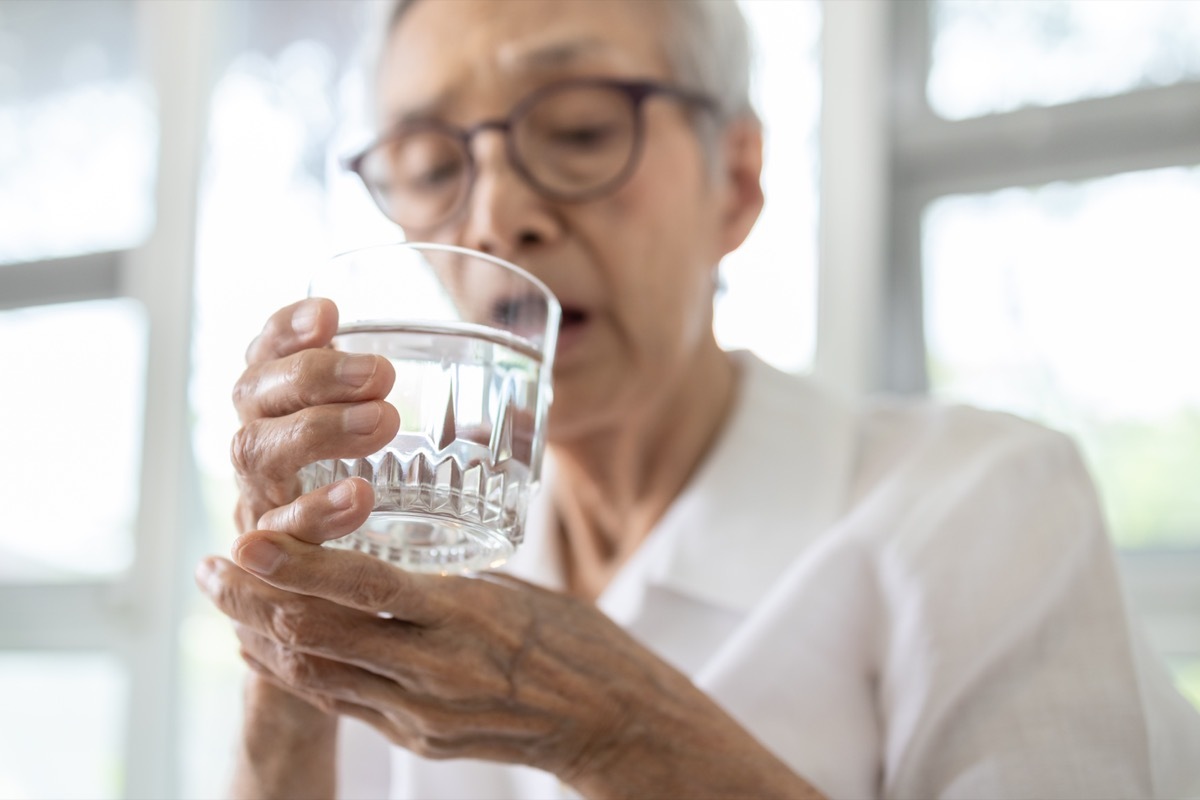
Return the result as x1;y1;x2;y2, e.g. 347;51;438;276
924;168;1200;547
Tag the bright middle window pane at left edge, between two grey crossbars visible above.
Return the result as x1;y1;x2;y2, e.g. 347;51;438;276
0;300;146;583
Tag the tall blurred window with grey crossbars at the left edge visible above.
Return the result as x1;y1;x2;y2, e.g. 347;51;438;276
0;0;211;798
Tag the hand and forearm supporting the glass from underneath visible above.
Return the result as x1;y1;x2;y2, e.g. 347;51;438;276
197;489;817;798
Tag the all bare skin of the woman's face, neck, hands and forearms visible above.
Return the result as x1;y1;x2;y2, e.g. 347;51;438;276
204;1;816;798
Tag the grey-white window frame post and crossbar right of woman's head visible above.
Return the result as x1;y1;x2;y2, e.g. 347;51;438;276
816;0;1200;671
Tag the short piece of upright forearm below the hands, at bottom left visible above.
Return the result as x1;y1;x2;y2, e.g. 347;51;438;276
230;674;337;800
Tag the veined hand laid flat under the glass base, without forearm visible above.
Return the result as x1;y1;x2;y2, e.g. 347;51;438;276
199;527;648;780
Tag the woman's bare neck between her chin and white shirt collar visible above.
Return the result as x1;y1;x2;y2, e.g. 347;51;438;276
554;342;737;600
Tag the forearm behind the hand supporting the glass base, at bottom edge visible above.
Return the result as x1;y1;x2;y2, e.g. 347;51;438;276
570;687;823;800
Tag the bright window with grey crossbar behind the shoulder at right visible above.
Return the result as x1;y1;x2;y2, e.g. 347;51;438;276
877;0;1200;699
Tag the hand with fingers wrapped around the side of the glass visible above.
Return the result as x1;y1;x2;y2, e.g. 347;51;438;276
230;299;400;533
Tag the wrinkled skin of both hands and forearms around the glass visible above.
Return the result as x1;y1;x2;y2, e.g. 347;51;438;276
208;301;806;796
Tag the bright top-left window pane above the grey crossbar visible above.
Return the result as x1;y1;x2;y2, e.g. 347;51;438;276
0;0;157;261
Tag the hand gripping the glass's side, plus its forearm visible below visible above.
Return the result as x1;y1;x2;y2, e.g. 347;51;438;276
230;300;400;798
